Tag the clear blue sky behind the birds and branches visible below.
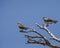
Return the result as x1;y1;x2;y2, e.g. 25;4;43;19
0;0;60;48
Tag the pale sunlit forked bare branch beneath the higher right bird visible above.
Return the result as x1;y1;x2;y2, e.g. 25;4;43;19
36;23;60;42
